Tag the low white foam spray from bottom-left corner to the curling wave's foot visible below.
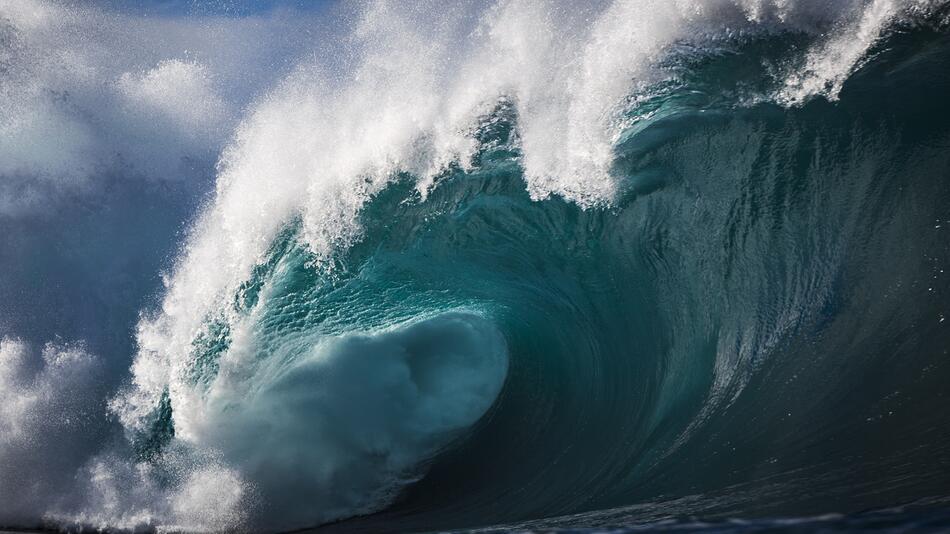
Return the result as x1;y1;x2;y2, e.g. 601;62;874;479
0;338;242;531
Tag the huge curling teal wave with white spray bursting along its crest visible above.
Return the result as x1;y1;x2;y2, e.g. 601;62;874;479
0;0;950;532
